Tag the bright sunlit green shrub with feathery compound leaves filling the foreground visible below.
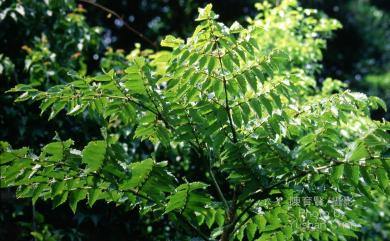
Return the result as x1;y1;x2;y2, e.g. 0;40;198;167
0;1;390;241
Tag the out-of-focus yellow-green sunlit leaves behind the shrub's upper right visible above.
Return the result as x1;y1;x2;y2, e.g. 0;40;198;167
249;1;341;74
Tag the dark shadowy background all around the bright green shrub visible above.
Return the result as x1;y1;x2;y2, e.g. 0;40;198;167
0;0;390;240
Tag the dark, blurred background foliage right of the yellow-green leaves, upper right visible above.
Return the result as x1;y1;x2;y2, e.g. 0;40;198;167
305;0;390;120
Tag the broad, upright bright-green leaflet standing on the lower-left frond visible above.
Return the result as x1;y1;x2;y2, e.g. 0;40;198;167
82;141;107;172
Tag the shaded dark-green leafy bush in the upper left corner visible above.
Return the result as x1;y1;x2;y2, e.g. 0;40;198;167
0;0;102;87
